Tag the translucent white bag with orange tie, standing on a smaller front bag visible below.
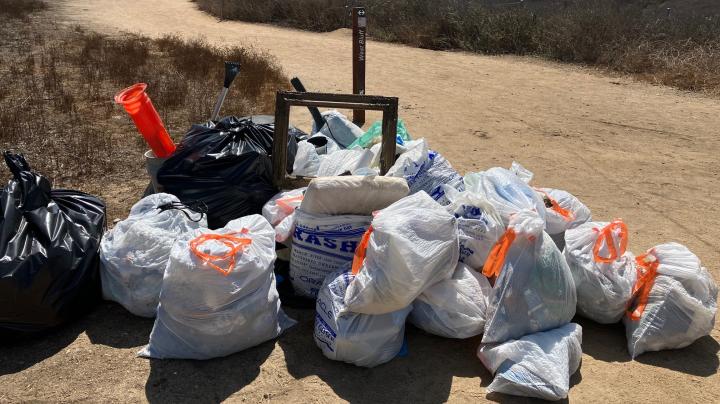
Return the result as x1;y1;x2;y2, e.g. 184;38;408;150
482;210;577;343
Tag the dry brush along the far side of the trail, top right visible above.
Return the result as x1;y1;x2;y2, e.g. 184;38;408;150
195;0;720;95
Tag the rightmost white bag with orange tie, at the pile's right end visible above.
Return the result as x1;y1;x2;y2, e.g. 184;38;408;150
623;243;718;358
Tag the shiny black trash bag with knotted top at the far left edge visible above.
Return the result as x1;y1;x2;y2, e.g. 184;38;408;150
0;152;105;339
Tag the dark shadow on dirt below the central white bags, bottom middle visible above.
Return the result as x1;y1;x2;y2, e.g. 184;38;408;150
278;309;491;403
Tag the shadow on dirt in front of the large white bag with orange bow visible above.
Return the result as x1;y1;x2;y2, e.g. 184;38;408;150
145;340;275;403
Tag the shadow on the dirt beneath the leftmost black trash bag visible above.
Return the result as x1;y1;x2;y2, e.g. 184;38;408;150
0;310;90;376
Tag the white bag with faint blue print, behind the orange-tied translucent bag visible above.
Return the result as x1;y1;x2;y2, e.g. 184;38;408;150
465;167;545;228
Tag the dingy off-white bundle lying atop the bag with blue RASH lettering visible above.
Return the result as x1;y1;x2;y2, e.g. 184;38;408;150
300;175;409;215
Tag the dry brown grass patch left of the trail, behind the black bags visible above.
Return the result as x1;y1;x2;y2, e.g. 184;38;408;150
0;0;289;215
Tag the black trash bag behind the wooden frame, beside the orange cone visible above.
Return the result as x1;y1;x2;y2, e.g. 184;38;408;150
157;116;306;229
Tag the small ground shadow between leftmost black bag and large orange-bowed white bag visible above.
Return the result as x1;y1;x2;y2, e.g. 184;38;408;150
85;301;154;348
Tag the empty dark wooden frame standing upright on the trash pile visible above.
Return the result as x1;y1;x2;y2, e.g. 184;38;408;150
272;91;398;189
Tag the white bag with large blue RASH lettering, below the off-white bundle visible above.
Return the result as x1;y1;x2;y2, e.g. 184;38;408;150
290;209;372;298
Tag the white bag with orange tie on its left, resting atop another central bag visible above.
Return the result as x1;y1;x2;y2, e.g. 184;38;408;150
345;192;459;314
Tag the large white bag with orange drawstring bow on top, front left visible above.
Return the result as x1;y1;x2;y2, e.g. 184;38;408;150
139;215;294;359
